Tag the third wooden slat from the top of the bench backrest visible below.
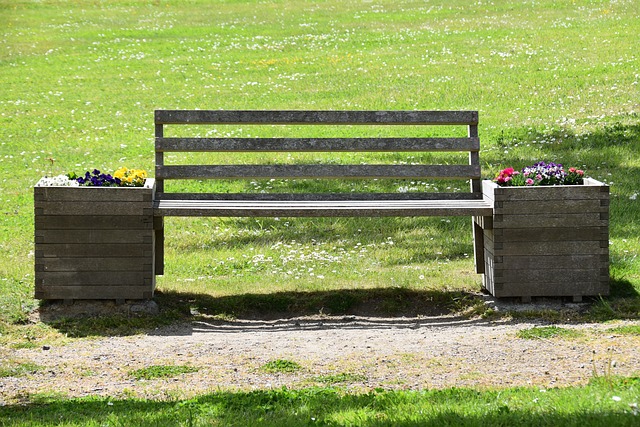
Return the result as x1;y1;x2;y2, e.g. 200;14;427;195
156;165;480;179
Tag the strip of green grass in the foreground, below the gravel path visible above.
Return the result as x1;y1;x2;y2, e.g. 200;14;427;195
0;378;640;427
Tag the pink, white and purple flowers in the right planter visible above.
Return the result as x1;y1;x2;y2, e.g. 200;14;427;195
495;162;584;187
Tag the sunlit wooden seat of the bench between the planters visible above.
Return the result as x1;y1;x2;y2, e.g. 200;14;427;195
155;200;492;217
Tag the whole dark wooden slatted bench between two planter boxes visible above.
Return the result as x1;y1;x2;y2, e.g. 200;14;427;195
153;110;492;274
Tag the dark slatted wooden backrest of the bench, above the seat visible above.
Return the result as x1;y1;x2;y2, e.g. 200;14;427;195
155;110;482;200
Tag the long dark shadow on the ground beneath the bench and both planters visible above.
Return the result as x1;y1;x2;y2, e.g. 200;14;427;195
34;279;640;337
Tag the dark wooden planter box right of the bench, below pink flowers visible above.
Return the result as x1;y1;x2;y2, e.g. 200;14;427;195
476;178;609;301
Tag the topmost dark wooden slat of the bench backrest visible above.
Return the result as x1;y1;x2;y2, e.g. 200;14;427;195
155;110;478;125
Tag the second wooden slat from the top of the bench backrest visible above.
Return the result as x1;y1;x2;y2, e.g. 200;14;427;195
156;138;480;152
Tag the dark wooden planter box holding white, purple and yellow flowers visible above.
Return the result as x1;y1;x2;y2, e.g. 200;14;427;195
34;179;155;300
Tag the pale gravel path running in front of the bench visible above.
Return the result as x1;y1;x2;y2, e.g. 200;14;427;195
0;300;640;404
